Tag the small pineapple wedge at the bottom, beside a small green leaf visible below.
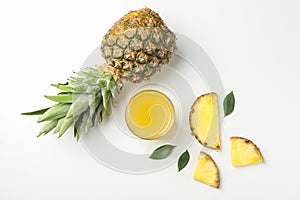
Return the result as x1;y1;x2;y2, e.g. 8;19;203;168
194;151;220;188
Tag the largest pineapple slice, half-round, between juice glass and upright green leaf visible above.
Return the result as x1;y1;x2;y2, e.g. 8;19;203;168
190;93;220;150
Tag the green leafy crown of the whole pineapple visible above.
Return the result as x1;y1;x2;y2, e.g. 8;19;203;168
23;66;123;140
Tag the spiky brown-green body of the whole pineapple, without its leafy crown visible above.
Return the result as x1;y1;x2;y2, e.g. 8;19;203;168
101;8;176;83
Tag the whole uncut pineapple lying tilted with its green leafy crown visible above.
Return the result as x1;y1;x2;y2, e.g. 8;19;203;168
22;8;176;140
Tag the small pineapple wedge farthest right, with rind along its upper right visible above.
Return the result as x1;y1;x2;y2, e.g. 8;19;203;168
230;137;263;166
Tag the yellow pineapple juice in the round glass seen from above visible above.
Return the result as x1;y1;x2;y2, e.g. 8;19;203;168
125;90;175;140
